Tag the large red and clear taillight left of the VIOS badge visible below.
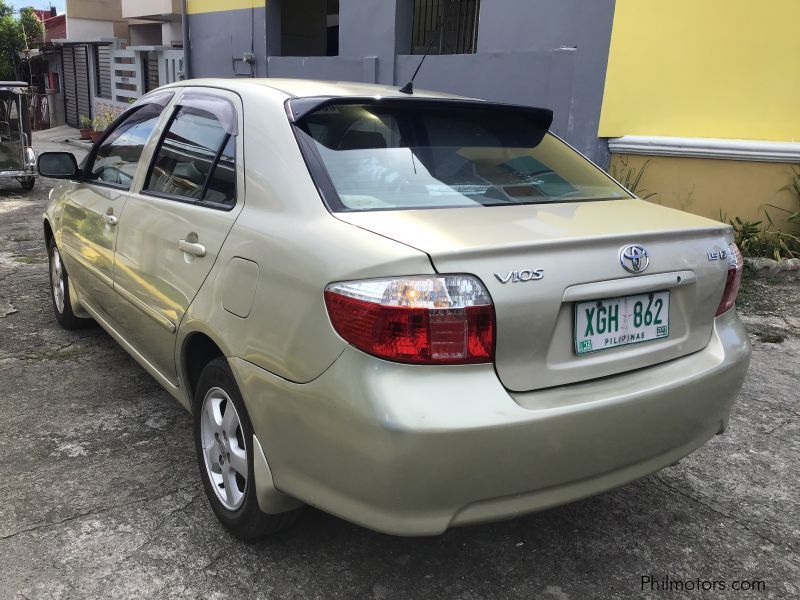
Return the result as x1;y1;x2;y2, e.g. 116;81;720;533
325;275;495;364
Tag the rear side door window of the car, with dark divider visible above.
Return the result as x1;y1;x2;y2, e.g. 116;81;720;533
143;106;236;208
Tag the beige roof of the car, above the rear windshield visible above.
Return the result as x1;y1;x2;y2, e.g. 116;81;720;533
170;77;464;99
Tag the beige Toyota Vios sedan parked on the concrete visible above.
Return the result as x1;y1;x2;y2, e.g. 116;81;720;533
39;79;750;537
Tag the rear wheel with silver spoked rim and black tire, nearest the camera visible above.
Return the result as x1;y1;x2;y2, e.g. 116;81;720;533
192;358;300;540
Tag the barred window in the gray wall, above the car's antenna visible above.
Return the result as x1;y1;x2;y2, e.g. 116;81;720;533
411;0;480;54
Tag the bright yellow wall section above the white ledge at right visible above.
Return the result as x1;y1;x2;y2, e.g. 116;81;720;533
600;0;800;141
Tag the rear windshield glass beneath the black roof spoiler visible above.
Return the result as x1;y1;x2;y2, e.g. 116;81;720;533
296;100;630;211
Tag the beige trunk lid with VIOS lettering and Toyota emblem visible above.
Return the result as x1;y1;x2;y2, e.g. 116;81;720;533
335;199;729;391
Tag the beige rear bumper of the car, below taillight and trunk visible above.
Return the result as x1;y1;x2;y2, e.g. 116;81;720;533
231;311;750;535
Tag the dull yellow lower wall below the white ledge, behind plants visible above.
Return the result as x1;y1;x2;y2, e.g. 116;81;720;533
610;154;800;224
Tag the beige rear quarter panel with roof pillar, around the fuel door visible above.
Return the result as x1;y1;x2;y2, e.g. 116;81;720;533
176;88;433;382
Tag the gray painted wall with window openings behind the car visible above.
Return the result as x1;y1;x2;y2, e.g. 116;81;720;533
188;0;615;164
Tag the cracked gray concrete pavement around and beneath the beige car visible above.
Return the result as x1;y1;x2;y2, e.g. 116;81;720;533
0;134;800;600
